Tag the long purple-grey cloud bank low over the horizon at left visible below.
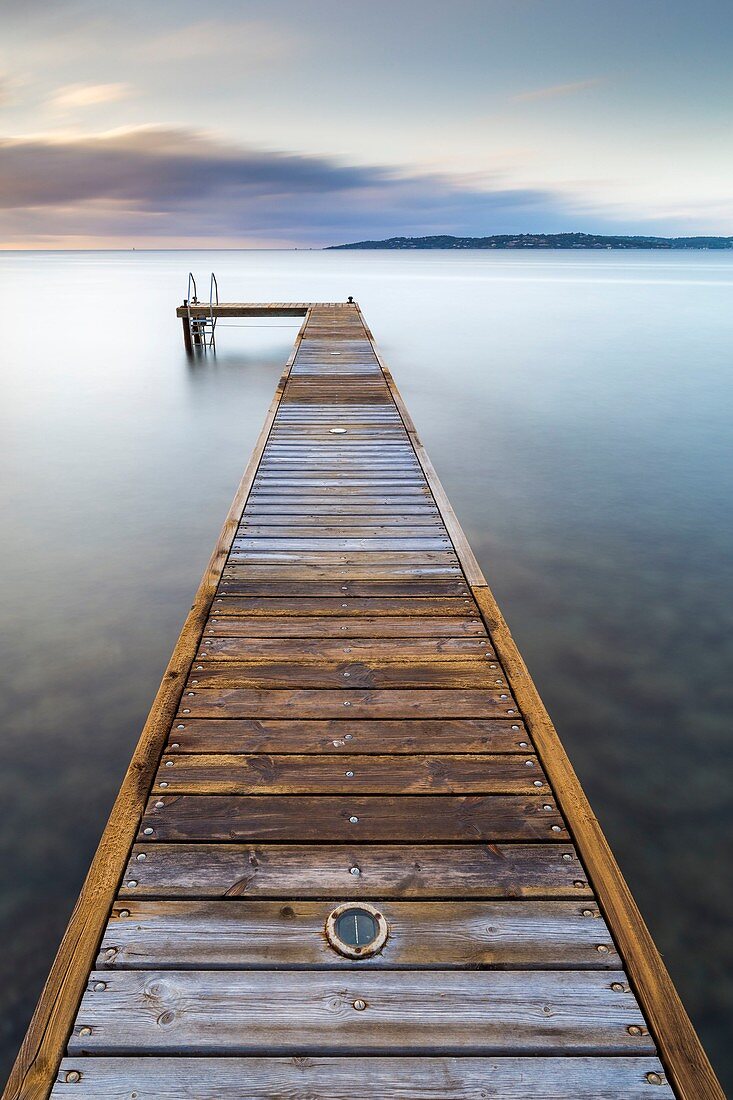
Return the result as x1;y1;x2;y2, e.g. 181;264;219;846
0;128;569;245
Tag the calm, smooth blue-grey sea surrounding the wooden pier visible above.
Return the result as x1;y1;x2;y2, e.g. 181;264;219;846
0;251;733;1082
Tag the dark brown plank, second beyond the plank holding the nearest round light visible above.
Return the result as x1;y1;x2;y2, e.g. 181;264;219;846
139;792;568;843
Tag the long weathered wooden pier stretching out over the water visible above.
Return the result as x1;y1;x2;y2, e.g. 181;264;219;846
4;304;723;1100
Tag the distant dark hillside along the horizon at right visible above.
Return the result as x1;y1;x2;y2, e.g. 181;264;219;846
329;233;733;249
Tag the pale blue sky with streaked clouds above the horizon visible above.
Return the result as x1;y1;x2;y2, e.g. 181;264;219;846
0;0;733;249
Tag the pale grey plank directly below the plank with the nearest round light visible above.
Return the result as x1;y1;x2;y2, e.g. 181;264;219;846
68;970;654;1055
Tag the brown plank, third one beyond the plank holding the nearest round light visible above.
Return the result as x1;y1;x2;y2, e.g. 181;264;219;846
150;752;548;794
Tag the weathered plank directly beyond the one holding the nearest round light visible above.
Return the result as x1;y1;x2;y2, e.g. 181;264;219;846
120;840;593;909
